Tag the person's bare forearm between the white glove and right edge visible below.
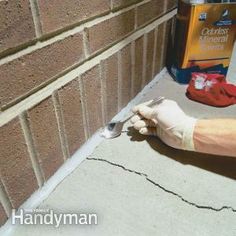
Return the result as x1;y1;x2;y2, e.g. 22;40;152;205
193;119;236;157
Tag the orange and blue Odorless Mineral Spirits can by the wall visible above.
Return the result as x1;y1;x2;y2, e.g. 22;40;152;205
168;0;236;84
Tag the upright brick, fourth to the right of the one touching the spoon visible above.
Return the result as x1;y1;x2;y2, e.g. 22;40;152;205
154;22;166;75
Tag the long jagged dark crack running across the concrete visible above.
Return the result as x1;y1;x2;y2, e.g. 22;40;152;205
87;157;236;212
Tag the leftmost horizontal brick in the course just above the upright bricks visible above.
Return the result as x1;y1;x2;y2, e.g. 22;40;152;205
0;33;84;110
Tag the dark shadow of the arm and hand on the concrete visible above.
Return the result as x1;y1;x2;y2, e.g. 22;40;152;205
127;127;236;179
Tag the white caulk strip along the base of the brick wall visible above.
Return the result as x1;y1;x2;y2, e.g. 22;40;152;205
0;68;167;233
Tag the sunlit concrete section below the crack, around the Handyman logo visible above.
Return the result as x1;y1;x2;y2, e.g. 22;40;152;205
10;157;236;236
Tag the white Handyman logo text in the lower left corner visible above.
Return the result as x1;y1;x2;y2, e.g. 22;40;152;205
11;209;98;228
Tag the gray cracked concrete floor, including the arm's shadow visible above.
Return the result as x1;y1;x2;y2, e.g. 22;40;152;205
8;48;236;236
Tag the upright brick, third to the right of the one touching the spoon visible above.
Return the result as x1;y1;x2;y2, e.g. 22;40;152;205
145;30;154;83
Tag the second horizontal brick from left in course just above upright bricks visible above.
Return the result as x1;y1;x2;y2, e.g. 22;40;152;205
86;10;134;54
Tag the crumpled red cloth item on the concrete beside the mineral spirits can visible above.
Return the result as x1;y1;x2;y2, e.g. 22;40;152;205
186;73;236;107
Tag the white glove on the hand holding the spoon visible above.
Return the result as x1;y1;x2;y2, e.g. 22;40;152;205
131;99;197;151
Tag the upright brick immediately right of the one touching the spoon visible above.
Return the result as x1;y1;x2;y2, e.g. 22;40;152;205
120;44;132;108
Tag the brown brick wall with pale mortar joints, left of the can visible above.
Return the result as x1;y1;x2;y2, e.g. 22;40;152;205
0;0;176;224
